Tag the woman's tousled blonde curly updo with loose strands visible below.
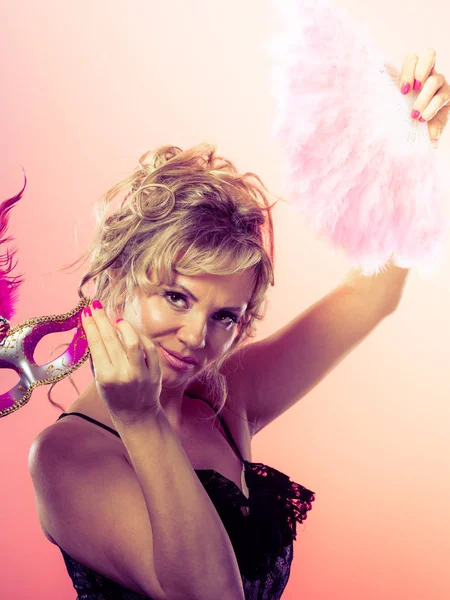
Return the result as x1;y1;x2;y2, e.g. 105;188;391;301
49;143;281;420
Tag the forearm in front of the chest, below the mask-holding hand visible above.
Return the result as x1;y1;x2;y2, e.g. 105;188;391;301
115;412;244;600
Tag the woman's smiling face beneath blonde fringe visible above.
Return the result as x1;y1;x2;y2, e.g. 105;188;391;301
119;270;253;387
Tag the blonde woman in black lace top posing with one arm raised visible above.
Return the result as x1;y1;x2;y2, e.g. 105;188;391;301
30;50;450;600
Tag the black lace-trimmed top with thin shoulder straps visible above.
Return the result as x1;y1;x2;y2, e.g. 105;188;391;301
54;394;315;600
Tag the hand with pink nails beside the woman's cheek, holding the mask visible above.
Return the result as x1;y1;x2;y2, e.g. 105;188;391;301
82;300;162;425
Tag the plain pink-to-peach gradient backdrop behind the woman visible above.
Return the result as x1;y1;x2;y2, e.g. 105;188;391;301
0;0;450;600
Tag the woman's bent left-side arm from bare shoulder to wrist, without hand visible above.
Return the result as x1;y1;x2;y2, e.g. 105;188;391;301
29;413;244;600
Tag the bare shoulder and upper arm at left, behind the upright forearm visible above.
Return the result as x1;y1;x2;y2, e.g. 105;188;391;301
28;420;165;599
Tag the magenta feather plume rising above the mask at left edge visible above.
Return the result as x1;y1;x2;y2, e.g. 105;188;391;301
0;172;27;321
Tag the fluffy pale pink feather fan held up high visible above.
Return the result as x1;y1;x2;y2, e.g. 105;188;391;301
268;0;450;275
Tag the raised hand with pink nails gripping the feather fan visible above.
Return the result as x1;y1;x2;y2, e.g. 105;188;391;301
400;48;450;146
